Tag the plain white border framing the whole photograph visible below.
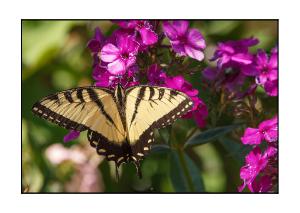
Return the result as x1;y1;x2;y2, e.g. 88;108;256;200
0;0;300;213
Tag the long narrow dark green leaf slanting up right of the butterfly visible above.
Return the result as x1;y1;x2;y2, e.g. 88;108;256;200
184;124;242;148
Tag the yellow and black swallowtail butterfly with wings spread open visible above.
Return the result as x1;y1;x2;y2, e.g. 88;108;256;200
32;85;193;178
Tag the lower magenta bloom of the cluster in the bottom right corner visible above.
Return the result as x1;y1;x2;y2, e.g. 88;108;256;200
238;146;277;192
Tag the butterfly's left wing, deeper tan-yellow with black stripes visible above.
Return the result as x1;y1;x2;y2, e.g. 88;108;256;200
32;87;126;165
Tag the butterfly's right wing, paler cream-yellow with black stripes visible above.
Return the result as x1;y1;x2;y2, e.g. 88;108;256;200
125;86;193;157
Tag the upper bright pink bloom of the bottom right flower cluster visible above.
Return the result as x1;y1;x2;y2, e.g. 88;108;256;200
241;116;278;145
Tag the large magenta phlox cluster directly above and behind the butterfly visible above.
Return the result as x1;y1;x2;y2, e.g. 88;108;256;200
64;20;208;142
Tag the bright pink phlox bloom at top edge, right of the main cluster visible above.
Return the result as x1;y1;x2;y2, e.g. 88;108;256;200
163;21;206;61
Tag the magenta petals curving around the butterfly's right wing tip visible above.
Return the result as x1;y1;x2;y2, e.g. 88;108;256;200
165;75;208;128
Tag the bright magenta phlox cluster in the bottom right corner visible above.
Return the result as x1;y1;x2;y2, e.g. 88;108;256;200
239;116;278;192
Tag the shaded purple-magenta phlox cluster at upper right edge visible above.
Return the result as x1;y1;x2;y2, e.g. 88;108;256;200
202;38;278;98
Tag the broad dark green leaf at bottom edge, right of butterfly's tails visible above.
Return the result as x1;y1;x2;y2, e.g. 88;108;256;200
170;150;204;192
